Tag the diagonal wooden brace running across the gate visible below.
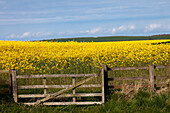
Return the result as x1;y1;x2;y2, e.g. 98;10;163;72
35;75;97;105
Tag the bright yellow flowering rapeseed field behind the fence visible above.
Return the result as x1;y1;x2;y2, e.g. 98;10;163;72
0;40;170;73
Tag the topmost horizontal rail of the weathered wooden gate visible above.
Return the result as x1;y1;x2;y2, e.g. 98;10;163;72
17;74;98;78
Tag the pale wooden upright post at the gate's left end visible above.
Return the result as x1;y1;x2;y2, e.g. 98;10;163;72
12;70;18;102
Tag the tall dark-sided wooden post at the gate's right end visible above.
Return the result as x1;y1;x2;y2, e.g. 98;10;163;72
102;65;108;103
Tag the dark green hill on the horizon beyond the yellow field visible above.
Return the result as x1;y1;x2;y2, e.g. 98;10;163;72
42;35;170;42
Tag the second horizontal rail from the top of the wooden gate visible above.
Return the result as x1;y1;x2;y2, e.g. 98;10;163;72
18;84;101;89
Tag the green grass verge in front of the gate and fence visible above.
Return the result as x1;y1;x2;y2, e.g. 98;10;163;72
0;91;170;113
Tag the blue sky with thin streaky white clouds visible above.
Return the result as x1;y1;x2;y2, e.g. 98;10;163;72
0;0;170;41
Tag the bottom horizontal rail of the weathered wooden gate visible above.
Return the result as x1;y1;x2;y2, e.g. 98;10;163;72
23;102;102;106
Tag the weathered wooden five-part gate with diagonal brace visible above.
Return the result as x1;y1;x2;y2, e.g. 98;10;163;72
12;69;106;105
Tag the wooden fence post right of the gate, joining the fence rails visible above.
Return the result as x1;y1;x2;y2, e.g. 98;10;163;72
149;65;155;91
